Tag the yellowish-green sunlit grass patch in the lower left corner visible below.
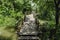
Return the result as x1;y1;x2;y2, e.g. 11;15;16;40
0;27;17;40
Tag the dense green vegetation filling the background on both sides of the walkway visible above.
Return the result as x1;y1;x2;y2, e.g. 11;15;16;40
0;0;59;40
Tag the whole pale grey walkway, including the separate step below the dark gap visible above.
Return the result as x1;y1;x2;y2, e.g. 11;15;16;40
18;14;39;40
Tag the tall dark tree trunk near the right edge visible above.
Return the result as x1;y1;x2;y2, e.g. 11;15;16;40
54;0;60;40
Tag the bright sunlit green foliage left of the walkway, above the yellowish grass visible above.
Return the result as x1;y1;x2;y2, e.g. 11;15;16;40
0;0;23;26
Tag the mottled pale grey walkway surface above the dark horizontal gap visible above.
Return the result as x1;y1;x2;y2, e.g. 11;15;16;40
20;14;37;35
